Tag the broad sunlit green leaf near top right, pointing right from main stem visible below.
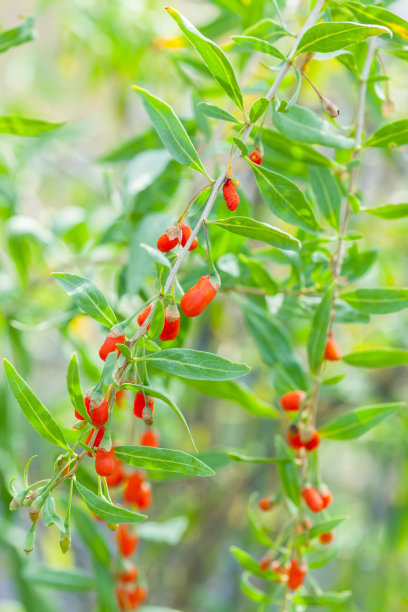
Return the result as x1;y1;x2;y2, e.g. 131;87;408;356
296;21;391;55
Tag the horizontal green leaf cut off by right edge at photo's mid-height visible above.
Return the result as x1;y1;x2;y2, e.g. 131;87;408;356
340;289;408;314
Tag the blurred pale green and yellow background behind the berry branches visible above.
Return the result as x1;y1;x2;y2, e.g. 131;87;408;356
0;0;408;612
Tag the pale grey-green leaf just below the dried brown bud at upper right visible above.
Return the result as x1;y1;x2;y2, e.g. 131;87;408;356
273;106;355;149
